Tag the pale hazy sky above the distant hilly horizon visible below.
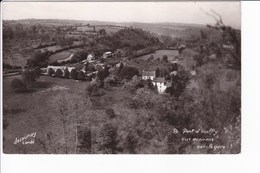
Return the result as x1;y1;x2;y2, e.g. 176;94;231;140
2;2;241;28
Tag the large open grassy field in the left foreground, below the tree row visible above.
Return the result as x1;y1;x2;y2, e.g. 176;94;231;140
3;76;89;153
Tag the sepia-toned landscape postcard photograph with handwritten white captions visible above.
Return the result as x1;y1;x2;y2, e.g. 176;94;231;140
1;1;241;155
